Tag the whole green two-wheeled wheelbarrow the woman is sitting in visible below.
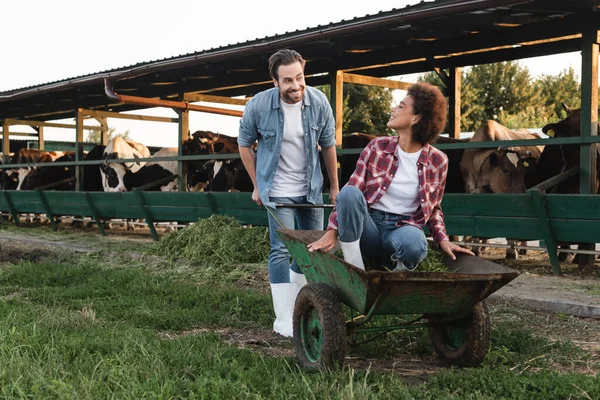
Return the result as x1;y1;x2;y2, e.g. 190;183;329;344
277;229;519;371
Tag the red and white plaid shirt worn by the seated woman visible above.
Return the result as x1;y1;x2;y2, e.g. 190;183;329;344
327;136;448;243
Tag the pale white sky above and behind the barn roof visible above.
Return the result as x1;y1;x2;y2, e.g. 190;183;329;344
0;0;581;146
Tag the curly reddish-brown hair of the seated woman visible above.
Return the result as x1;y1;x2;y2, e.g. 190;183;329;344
406;82;448;145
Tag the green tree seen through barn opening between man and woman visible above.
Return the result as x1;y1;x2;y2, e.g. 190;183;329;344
317;83;392;135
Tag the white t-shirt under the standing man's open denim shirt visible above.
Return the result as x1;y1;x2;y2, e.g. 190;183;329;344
269;100;308;197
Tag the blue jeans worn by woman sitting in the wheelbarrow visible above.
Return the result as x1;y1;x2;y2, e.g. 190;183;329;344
336;186;427;270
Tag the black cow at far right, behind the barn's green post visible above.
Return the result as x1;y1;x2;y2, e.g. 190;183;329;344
533;103;600;263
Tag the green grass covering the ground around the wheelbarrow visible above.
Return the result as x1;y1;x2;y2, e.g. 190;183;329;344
0;220;600;399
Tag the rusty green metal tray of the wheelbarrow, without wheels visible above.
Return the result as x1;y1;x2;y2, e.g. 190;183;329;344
278;229;519;318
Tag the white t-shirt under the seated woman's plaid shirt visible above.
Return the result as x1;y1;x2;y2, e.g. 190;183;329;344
371;146;423;215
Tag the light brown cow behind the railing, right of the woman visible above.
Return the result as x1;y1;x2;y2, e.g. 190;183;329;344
459;120;544;259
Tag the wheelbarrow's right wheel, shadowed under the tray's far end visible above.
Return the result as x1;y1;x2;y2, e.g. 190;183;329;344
429;301;490;367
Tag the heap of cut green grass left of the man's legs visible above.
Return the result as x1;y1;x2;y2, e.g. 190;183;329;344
151;215;270;266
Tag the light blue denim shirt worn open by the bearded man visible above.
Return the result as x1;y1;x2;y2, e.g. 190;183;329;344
238;86;335;207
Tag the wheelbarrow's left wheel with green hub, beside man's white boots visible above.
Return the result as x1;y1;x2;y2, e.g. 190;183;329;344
293;283;346;371
